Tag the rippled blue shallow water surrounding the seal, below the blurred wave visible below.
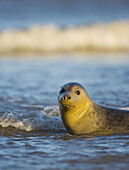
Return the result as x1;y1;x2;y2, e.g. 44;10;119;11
0;54;129;170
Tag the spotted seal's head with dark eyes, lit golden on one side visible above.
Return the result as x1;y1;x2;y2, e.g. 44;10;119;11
58;82;88;112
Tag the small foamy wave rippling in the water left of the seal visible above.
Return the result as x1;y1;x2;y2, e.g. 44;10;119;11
0;106;65;131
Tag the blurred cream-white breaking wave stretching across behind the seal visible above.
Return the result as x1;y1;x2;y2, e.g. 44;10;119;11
0;21;129;54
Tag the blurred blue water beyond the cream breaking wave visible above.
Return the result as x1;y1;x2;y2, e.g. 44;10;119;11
0;0;129;30
